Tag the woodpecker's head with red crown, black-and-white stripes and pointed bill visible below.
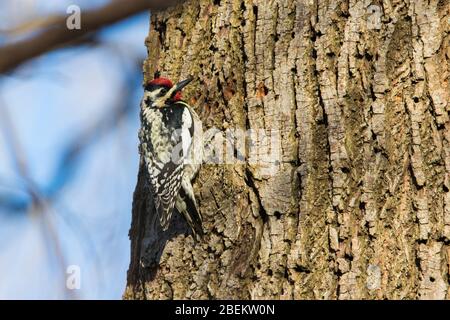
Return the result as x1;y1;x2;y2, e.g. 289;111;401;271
144;76;192;108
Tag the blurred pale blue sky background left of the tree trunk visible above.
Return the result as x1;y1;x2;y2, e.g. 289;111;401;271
0;0;153;299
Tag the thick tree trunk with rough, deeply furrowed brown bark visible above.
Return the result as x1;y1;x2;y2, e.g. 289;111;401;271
124;0;450;299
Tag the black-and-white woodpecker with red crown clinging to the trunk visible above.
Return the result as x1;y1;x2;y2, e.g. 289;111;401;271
139;77;203;238
